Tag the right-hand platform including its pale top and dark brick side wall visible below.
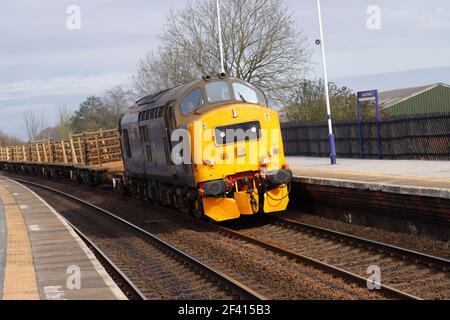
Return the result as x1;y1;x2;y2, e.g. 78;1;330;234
287;157;450;241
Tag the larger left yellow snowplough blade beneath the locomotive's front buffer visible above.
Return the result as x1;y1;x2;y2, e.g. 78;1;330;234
203;198;241;222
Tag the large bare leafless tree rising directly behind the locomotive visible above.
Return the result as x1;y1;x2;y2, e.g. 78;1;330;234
134;0;310;103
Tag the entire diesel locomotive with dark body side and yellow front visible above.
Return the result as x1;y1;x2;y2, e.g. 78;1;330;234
114;74;292;221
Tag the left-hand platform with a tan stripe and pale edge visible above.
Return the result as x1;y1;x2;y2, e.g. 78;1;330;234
0;176;126;300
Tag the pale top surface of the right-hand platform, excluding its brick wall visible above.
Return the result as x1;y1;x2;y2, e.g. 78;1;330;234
287;157;450;199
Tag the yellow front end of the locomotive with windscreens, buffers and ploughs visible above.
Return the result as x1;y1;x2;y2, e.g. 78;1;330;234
181;79;292;221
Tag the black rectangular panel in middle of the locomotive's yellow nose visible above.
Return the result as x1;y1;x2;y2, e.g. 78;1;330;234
215;121;261;145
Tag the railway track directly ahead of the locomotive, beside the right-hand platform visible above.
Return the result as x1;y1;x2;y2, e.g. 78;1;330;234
221;218;450;299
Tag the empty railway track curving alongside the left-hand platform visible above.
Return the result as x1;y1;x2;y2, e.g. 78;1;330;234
13;179;266;300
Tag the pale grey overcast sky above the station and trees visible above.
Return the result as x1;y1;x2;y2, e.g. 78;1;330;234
0;0;450;137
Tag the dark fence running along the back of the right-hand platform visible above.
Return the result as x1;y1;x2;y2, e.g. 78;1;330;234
282;113;450;160
